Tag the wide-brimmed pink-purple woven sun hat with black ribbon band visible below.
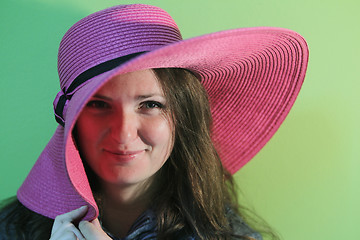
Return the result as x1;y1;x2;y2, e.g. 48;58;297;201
17;4;308;219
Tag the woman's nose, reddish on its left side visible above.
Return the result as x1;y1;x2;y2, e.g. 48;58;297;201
111;111;138;144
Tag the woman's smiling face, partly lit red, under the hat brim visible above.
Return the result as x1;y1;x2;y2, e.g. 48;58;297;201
76;70;173;189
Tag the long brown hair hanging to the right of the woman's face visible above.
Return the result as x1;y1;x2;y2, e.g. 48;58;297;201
150;68;237;239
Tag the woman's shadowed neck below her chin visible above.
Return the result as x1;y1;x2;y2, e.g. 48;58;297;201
101;177;155;237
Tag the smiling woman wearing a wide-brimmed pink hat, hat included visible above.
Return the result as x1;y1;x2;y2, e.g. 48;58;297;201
0;4;308;240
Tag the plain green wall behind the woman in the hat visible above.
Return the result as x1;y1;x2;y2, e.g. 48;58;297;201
0;0;360;240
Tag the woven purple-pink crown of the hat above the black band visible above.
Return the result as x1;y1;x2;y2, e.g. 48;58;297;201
58;4;182;89
